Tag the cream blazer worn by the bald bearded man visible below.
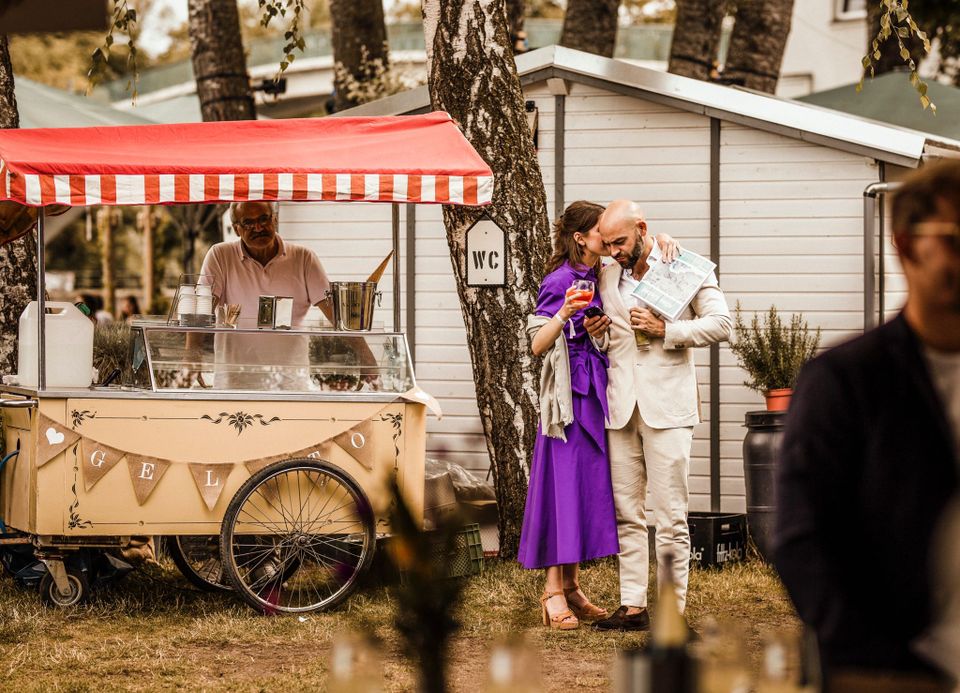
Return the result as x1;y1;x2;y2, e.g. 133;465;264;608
600;262;733;429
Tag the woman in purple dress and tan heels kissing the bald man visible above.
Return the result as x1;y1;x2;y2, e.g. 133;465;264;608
518;201;620;630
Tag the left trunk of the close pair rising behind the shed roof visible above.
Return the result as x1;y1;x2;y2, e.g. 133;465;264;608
667;0;726;81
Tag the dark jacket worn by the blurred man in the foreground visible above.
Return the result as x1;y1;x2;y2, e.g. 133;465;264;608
774;314;958;671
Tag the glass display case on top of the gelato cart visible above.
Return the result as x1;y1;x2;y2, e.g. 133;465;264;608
129;321;415;394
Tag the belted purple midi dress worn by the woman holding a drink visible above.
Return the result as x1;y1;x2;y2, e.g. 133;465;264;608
517;263;620;568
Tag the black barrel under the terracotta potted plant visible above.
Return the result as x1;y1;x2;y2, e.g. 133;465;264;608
743;411;787;560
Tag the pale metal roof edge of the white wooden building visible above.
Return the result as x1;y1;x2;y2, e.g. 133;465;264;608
337;46;927;167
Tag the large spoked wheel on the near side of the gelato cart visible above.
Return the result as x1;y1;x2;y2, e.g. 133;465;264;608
220;459;376;613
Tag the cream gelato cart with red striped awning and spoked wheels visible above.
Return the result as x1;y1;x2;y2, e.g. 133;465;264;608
0;113;493;613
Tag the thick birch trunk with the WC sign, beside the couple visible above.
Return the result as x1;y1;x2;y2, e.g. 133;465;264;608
423;0;550;557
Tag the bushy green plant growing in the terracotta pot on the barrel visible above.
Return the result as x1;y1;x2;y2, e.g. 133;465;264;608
730;301;820;392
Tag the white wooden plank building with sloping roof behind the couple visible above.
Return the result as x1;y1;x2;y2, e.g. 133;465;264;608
281;47;960;512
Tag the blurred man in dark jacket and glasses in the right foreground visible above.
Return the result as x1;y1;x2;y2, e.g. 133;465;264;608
775;162;960;689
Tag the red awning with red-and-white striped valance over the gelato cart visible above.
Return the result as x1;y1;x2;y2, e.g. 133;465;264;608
0;112;493;207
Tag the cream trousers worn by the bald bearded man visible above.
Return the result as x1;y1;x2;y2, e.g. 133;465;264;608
607;407;693;612
